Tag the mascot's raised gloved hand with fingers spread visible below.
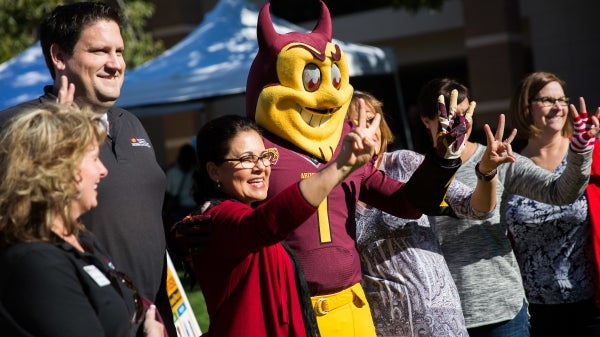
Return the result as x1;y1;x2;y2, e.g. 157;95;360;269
436;90;475;159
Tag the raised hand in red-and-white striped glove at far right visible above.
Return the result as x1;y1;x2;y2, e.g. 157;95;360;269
570;97;600;153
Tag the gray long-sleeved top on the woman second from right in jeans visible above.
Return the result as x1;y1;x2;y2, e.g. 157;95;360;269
430;144;592;328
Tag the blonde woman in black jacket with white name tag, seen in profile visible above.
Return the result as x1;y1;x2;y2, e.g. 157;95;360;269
0;103;163;337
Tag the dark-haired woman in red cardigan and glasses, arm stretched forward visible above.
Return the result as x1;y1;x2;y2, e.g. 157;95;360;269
178;109;380;337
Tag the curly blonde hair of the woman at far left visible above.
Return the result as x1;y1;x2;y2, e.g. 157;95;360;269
0;103;106;246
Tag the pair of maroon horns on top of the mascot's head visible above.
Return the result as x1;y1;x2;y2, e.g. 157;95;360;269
257;0;332;51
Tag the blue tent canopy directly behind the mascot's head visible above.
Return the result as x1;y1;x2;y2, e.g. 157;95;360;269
118;0;393;107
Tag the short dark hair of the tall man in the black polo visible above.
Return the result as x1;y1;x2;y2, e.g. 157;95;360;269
39;2;123;79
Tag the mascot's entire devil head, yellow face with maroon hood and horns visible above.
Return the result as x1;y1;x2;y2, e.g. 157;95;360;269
246;1;353;161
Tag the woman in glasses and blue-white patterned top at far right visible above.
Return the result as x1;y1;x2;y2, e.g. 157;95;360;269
502;72;600;337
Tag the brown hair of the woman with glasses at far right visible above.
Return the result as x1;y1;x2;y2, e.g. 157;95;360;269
510;71;573;139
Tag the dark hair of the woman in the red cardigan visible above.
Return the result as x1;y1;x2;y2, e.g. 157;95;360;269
194;115;262;205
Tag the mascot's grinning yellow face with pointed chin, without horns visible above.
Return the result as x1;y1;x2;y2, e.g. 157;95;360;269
255;43;353;161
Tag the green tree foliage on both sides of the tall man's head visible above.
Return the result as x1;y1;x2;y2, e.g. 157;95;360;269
0;0;164;69
